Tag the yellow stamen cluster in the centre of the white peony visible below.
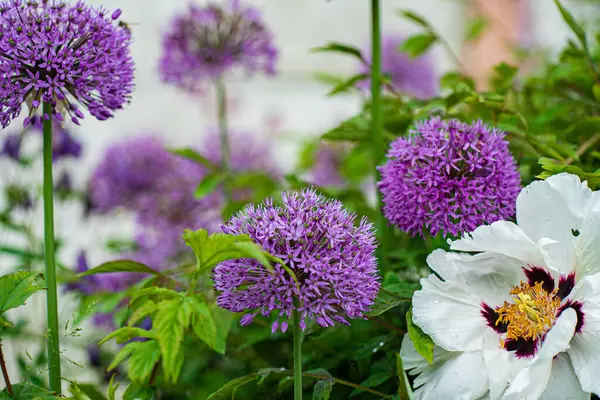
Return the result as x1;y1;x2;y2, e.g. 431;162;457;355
496;282;560;340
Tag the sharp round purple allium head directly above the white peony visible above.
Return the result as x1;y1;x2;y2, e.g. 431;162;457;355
378;117;521;236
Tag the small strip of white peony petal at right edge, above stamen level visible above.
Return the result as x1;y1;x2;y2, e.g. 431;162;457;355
574;211;600;279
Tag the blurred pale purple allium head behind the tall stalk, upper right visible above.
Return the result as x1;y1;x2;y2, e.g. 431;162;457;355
358;35;439;99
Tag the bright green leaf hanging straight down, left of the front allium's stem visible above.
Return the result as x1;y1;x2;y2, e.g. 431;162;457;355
152;300;191;384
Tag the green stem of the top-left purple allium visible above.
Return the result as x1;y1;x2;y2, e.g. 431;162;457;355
43;103;61;394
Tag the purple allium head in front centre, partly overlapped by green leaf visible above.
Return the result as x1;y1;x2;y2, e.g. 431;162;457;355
213;189;380;332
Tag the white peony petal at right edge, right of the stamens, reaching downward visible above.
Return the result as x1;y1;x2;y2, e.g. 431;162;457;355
567;273;600;394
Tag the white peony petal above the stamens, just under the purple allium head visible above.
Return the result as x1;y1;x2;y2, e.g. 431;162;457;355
450;221;546;267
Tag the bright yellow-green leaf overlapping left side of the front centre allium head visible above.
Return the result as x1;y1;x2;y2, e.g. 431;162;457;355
183;229;252;271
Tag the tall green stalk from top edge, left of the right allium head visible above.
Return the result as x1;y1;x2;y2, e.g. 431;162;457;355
371;0;387;249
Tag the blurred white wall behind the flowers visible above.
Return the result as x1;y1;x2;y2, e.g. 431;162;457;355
0;0;592;387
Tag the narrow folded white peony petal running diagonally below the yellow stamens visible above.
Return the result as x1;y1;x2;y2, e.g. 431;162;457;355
502;309;577;400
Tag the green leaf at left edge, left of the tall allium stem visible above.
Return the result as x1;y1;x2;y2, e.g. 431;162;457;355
0;271;45;314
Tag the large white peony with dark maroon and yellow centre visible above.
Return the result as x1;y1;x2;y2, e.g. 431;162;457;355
400;174;600;400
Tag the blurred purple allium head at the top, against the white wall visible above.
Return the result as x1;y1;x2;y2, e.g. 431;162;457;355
159;0;277;92
